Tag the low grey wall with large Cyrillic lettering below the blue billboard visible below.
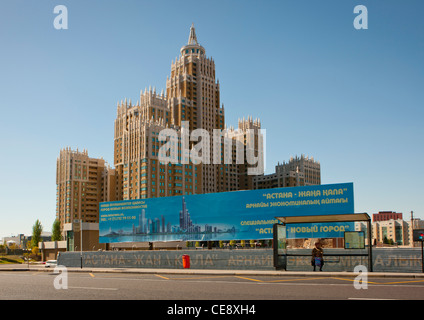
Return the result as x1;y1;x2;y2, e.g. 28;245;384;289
58;248;422;273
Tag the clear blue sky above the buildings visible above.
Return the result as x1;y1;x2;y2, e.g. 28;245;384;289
0;0;424;238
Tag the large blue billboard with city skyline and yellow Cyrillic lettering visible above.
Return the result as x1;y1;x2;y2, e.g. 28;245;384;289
99;183;354;243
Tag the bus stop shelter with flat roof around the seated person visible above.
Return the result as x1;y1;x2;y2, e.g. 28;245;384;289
273;213;373;272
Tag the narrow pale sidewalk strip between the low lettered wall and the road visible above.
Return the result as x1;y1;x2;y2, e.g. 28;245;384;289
0;265;424;279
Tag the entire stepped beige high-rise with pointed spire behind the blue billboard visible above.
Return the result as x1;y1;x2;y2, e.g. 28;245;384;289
114;25;263;200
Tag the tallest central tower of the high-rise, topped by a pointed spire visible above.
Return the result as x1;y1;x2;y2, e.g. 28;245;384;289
166;25;225;193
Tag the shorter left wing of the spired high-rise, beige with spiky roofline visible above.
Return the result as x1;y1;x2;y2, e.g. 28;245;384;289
114;88;201;200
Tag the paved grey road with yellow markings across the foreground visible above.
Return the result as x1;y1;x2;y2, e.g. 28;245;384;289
0;270;424;301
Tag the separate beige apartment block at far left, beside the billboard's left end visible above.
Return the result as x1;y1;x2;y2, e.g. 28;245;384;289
55;147;117;252
